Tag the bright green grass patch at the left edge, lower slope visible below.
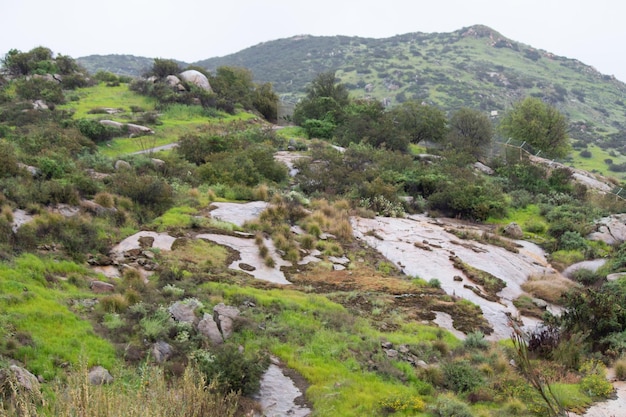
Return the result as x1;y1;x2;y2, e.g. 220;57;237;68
0;254;116;380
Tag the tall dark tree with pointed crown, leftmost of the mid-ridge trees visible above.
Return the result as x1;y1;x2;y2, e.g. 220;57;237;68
293;71;350;125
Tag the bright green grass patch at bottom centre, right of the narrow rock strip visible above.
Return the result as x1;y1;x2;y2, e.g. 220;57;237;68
197;283;461;416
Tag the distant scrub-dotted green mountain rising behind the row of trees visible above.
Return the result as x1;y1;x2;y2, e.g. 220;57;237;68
79;25;626;142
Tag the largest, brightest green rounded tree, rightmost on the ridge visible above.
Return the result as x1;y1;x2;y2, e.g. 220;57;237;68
500;97;570;158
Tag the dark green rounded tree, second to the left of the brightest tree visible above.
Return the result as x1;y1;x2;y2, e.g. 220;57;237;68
391;101;448;144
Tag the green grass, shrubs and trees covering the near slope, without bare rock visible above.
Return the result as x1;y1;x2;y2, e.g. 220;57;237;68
0;44;626;417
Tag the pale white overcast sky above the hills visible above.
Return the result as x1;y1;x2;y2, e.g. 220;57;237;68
0;0;626;82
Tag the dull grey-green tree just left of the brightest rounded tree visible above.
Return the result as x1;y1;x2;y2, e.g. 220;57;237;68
446;107;493;159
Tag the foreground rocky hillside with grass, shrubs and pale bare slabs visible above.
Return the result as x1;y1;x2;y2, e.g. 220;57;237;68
0;48;626;417
